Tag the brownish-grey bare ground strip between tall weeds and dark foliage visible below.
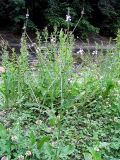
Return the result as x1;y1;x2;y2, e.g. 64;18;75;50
0;30;115;65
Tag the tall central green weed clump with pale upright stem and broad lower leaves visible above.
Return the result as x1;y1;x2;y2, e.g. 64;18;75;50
22;30;77;160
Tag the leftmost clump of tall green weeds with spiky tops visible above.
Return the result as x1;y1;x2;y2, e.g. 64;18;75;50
2;31;28;108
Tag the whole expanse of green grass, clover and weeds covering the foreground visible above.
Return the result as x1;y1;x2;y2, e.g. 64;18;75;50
0;30;120;160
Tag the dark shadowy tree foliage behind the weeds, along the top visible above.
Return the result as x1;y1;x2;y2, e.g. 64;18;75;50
0;0;120;36
